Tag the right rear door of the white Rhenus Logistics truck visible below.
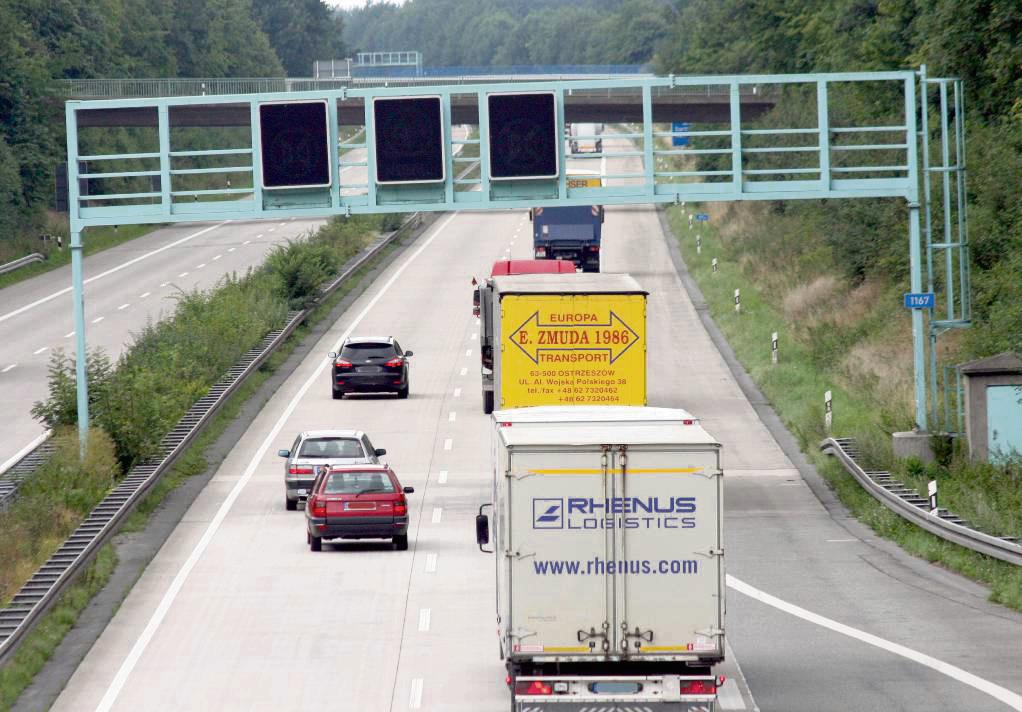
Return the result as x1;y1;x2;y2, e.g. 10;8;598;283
612;445;724;657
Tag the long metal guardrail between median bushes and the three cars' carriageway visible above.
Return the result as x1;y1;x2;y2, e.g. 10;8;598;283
0;155;473;665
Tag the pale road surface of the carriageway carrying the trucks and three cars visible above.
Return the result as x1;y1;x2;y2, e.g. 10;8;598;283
49;140;1022;712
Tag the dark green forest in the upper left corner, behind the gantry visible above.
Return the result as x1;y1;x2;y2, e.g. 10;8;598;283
0;0;345;263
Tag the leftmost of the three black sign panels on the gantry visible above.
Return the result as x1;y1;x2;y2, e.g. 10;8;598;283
259;101;330;188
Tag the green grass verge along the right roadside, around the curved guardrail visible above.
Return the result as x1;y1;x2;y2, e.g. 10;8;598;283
667;205;1022;610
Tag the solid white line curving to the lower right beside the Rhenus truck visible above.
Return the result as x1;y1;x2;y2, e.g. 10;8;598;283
727;574;1022;711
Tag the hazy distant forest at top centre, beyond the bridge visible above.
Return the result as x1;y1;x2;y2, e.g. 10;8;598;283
344;0;678;66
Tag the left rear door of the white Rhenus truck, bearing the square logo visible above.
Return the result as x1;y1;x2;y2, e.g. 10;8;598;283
507;448;613;656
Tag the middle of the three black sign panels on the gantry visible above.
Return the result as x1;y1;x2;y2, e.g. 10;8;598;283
373;96;446;184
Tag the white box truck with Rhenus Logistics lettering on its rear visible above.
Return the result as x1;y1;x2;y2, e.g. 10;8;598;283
475;406;725;712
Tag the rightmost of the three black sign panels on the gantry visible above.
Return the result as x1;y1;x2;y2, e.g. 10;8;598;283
486;92;558;181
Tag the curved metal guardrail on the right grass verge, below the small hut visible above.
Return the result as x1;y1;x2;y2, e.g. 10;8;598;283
820;437;1022;566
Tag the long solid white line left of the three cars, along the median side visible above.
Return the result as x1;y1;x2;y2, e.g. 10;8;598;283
96;212;458;712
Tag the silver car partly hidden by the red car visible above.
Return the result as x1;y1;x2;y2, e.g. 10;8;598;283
277;430;386;510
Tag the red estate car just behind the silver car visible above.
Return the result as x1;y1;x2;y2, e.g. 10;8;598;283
306;465;415;552
